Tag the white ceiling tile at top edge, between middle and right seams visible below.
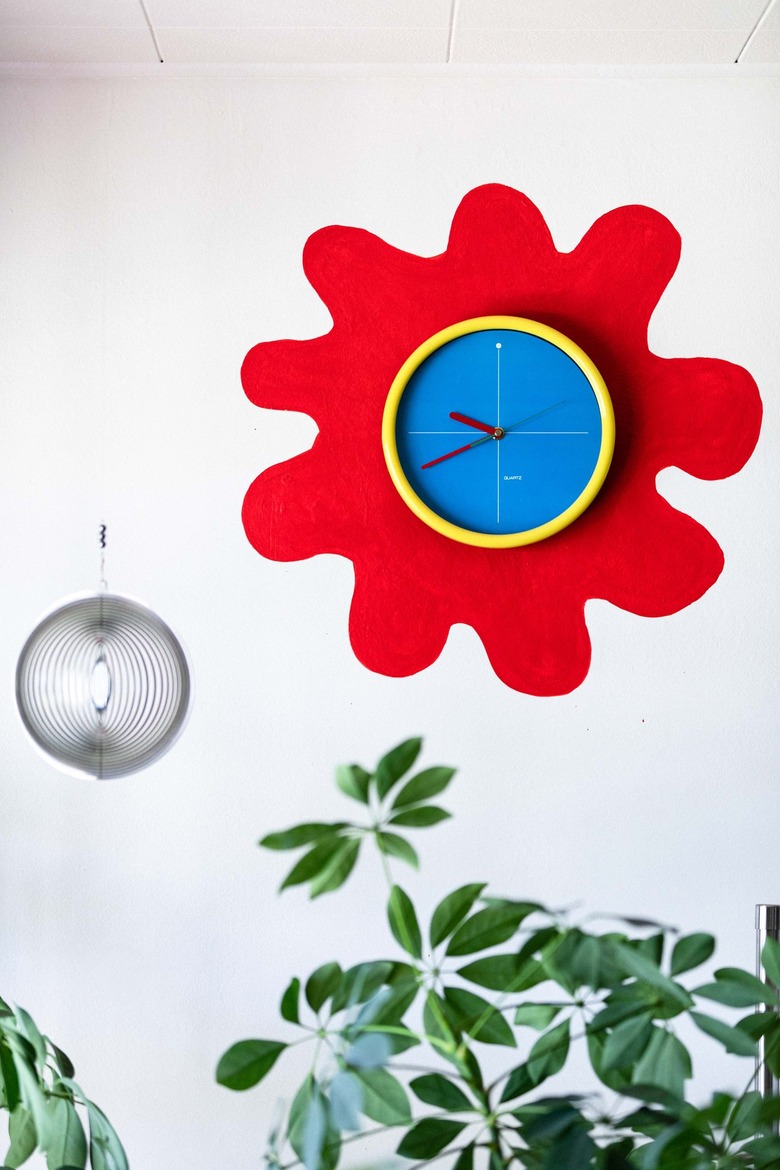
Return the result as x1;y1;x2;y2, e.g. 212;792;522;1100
456;0;766;33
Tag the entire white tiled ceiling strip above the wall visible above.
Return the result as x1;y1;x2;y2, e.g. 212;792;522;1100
0;0;780;66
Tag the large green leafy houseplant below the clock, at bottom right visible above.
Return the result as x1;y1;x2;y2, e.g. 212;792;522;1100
216;739;780;1170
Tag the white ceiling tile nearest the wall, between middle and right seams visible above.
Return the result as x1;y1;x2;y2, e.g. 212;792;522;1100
453;28;741;64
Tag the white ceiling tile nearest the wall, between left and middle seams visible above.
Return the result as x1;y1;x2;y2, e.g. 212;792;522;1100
156;27;447;64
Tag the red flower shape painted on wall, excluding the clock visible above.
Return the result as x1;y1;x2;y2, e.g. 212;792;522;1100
242;185;761;695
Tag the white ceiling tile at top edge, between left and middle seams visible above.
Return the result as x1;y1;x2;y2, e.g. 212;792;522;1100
146;0;451;28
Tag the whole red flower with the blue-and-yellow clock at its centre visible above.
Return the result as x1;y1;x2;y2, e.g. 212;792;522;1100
242;184;761;695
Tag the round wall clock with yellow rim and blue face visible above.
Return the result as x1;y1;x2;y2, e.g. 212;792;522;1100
384;317;614;548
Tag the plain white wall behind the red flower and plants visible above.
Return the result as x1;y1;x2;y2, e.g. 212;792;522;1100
0;69;780;1170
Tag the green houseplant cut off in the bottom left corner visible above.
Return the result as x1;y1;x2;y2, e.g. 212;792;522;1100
0;999;127;1170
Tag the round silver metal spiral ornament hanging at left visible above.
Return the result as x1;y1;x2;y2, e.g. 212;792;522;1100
16;592;192;780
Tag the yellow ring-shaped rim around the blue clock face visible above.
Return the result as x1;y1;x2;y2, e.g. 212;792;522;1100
382;316;615;549
